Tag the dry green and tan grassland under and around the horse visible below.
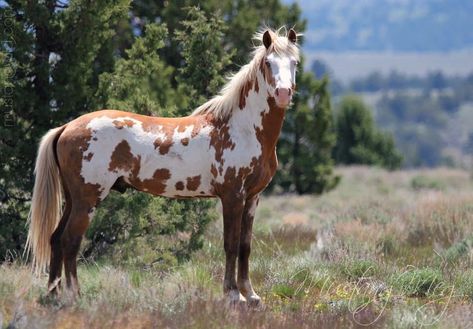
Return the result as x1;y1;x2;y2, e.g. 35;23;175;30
0;167;473;329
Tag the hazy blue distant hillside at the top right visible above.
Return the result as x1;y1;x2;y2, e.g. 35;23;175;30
292;0;473;52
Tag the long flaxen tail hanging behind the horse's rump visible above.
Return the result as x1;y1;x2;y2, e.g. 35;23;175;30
25;126;65;273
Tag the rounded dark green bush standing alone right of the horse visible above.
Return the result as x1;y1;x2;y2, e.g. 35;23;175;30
334;96;402;169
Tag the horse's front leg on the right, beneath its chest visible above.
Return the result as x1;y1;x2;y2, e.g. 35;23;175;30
238;195;261;306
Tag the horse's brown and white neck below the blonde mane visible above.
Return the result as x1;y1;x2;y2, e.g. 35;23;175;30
229;73;285;152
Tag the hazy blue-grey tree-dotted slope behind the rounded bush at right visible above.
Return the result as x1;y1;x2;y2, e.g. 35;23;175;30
311;60;473;168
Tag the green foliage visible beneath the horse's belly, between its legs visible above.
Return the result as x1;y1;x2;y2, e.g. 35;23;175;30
84;192;216;268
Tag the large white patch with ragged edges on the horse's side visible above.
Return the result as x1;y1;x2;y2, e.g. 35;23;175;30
81;115;215;199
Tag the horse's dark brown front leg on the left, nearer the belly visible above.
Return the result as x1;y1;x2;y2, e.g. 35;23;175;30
222;193;246;305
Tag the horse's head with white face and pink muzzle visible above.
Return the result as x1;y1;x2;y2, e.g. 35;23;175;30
262;29;299;107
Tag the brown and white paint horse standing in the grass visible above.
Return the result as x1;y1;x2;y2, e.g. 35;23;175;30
26;29;299;304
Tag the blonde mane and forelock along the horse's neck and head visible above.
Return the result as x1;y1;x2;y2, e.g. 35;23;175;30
191;27;299;119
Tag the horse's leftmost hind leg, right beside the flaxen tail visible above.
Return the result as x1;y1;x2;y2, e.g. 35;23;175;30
48;188;72;295
